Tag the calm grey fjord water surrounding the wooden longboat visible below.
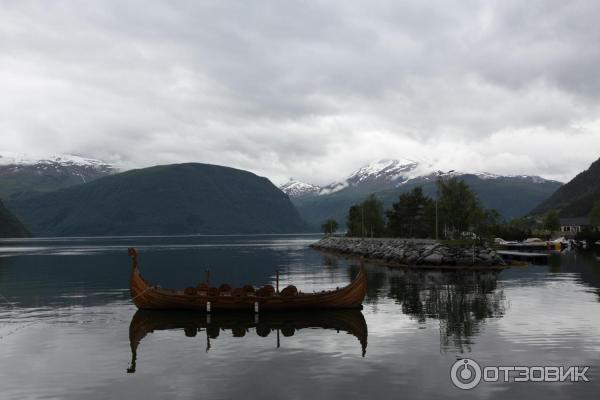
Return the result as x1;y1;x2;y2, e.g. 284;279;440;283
0;235;600;399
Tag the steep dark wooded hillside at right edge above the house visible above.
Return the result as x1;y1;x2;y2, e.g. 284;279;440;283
531;159;600;217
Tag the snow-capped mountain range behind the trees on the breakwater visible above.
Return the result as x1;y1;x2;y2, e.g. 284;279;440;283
290;160;561;229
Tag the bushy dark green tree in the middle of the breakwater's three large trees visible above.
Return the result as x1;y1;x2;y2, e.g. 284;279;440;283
386;186;435;238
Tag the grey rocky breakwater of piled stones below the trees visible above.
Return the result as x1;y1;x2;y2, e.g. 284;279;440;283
311;236;505;267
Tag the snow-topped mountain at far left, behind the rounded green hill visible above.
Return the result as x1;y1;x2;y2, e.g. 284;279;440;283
0;152;117;199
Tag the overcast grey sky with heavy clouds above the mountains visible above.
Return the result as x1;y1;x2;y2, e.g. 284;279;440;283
0;0;600;184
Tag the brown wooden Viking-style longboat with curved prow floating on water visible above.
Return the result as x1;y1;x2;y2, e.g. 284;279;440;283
129;248;367;312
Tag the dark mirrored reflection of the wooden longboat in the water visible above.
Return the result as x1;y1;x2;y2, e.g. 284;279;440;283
127;309;368;373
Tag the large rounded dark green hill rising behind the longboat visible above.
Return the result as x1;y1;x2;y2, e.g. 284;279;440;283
10;164;306;236
